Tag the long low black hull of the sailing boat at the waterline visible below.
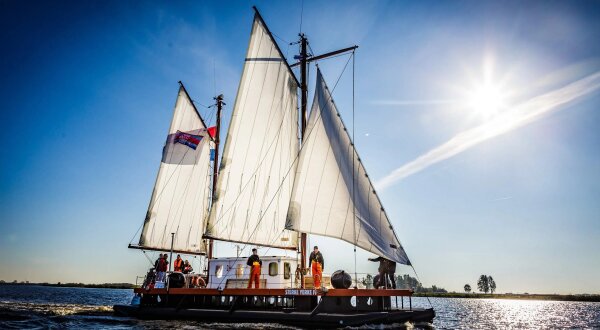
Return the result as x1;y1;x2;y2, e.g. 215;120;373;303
114;305;435;328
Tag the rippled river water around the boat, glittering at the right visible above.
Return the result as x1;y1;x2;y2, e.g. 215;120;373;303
0;285;600;329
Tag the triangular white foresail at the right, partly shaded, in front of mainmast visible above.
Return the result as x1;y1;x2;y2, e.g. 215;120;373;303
286;70;409;264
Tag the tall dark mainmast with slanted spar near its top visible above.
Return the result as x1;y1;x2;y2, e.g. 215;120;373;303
290;33;358;288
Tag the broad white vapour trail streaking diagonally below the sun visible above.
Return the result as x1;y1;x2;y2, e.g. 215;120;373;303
375;71;600;189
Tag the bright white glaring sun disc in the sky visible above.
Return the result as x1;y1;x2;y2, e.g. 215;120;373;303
467;82;506;119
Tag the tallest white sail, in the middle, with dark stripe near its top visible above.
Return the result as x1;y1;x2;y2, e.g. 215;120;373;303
205;15;299;249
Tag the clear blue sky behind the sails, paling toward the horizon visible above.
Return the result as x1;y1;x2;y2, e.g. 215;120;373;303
0;1;600;293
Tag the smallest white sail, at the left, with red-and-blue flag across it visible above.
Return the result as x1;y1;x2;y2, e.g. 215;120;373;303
138;86;214;254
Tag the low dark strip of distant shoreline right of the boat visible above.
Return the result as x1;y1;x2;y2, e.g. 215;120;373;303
413;292;600;302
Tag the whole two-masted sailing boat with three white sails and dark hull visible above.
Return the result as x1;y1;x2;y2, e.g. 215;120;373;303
114;8;435;327
